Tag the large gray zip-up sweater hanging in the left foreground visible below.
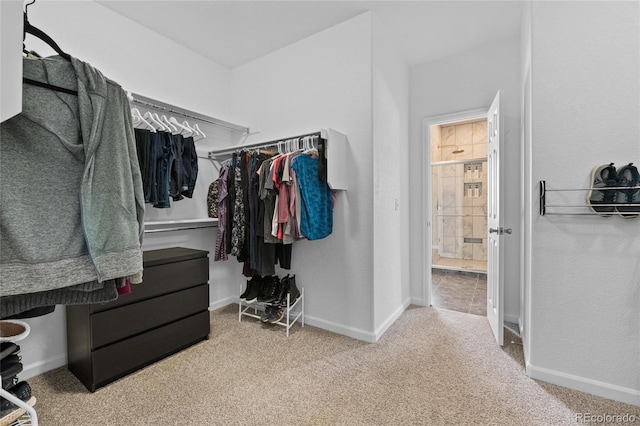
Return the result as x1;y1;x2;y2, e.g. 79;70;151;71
0;56;144;296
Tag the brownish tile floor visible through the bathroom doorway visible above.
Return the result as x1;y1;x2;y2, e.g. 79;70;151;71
431;268;487;316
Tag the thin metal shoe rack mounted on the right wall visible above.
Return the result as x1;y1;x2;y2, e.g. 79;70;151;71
540;180;640;216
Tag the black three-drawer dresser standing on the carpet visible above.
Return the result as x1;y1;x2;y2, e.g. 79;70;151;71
67;247;209;392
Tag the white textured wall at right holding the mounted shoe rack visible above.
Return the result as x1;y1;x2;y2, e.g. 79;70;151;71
527;2;640;405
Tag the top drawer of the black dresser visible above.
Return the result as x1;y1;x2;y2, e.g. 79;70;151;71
90;257;209;313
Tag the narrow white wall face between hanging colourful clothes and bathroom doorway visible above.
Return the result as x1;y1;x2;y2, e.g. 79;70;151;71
372;15;410;339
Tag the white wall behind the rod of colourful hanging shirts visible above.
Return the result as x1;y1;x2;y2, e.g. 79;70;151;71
232;13;374;341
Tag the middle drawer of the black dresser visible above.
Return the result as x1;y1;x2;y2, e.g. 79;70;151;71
90;284;209;349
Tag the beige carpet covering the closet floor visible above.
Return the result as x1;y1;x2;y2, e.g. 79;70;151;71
29;305;640;426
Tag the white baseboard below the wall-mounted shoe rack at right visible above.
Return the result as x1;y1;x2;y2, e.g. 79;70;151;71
527;364;640;406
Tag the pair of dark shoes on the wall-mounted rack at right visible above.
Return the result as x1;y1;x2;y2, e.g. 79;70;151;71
587;163;640;219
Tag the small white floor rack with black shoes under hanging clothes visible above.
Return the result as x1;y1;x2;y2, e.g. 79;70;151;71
238;275;304;337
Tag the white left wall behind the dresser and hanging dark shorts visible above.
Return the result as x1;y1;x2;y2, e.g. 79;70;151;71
17;0;235;379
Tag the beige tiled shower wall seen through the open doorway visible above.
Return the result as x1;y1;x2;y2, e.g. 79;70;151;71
431;121;487;263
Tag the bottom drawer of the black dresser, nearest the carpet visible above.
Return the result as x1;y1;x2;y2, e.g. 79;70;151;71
90;311;209;391
